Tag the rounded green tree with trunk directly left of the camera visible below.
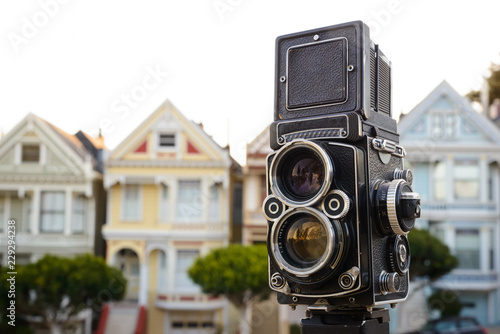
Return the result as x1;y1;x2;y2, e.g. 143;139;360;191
188;245;269;334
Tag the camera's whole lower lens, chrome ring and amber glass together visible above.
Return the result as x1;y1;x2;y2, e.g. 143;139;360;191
270;208;339;277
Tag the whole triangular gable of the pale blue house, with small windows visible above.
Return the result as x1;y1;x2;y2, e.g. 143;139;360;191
398;81;500;146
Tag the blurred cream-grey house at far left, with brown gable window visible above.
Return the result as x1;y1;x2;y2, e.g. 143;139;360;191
0;113;106;265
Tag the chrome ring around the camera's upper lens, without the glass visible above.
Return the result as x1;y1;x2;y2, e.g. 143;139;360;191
269;139;333;208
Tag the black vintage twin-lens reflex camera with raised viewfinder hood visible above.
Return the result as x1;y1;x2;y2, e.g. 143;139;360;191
263;21;420;310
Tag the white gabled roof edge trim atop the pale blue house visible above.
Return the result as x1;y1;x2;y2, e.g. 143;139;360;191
398;80;500;145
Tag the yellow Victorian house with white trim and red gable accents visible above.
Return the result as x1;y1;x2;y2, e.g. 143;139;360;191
103;100;234;333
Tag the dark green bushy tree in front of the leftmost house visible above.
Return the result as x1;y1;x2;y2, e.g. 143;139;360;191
0;254;126;334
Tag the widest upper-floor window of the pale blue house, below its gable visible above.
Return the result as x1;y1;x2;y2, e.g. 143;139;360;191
453;159;479;199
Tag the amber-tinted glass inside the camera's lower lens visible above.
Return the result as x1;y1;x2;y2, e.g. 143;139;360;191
285;215;327;268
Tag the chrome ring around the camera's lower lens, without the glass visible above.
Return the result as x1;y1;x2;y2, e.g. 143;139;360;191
270;207;335;277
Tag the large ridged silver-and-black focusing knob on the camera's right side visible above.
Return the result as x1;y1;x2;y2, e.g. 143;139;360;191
375;179;420;235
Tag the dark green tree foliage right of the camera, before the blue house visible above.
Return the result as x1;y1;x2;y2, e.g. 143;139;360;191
408;228;458;282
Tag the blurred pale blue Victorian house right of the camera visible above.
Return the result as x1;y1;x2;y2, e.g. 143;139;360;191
398;82;500;330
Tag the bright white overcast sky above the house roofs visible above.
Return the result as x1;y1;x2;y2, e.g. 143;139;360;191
0;0;500;163
